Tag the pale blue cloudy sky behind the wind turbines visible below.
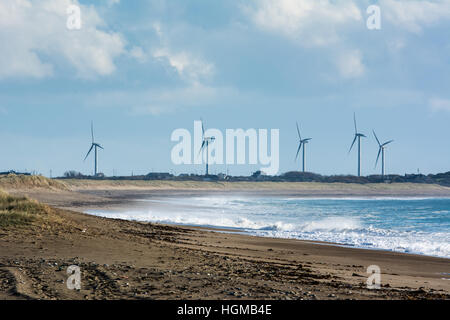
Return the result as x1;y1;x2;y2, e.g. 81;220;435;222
0;0;450;176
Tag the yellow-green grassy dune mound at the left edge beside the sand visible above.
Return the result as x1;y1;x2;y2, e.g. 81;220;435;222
0;191;58;229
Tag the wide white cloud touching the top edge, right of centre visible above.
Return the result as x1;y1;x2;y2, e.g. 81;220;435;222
243;0;362;46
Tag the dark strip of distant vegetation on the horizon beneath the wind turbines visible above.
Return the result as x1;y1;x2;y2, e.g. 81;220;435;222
58;171;450;186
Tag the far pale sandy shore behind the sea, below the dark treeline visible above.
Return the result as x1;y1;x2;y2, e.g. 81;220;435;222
7;178;450;211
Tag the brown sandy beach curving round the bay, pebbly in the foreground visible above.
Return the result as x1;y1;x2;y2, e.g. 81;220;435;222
0;178;450;299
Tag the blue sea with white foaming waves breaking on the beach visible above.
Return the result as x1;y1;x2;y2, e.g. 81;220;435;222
86;195;450;258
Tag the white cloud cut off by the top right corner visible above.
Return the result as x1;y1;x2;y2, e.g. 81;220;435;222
379;0;450;33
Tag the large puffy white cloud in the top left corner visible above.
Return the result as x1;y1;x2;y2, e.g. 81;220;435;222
0;0;126;78
